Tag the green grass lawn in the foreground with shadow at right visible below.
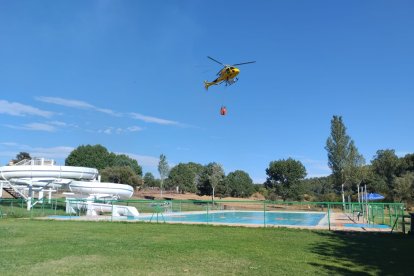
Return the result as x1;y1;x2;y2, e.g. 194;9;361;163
0;218;414;275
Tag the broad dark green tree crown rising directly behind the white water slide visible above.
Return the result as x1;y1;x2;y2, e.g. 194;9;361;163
65;145;114;170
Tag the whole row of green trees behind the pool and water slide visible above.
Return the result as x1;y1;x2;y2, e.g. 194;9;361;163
7;116;414;205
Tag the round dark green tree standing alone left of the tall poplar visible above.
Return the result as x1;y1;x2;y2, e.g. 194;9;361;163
265;158;306;201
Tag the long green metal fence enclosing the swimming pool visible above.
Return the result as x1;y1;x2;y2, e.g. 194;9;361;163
0;198;409;233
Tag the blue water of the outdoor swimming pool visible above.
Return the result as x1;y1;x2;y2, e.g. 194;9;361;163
134;211;326;226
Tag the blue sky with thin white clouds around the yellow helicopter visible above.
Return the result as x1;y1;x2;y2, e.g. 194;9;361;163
0;0;414;183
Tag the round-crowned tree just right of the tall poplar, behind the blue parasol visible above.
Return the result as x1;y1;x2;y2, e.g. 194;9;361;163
371;149;400;201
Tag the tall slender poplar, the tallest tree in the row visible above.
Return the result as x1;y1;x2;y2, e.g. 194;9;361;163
325;116;365;204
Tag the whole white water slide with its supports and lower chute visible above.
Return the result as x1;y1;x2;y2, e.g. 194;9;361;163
0;158;139;216
